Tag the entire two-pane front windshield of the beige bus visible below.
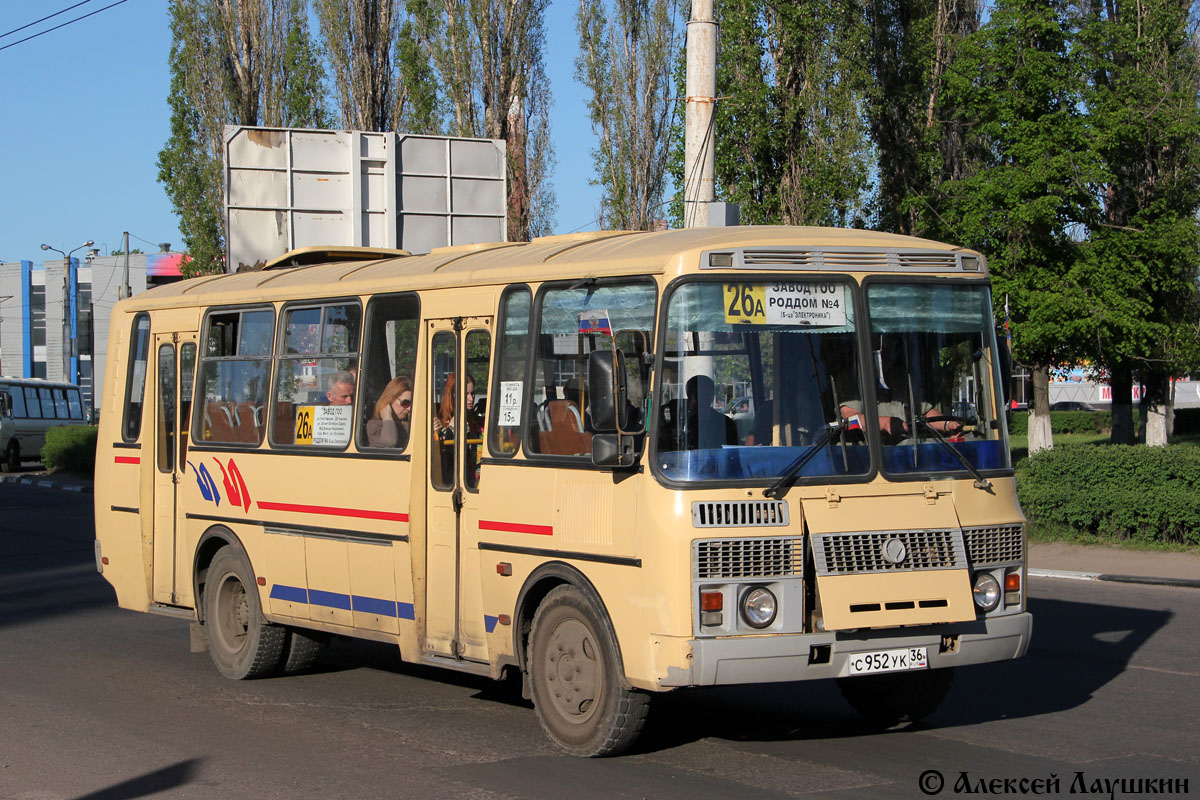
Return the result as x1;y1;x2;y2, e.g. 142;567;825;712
654;276;1008;483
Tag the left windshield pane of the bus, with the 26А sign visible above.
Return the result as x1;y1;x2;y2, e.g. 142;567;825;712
656;277;871;481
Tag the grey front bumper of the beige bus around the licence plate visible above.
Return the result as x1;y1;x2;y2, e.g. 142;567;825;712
660;612;1033;688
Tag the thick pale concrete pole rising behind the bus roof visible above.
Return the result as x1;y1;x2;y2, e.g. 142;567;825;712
683;0;716;228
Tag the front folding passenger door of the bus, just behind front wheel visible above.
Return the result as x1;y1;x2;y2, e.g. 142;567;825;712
424;317;492;661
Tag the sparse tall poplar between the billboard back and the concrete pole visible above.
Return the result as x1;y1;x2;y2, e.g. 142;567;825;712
575;0;682;230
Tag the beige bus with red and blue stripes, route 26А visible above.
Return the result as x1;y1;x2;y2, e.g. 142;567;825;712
95;227;1032;756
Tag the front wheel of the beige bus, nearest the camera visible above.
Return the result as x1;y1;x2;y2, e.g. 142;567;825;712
527;585;649;757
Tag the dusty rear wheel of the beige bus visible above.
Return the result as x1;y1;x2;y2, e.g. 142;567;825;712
204;545;287;680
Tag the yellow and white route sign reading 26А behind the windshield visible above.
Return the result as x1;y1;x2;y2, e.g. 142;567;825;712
724;282;846;325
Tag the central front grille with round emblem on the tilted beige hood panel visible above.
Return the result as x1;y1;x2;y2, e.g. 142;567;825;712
812;529;966;576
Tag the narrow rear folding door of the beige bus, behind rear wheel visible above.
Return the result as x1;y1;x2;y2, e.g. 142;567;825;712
152;332;196;604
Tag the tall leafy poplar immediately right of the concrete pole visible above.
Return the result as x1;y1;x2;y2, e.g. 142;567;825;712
672;0;871;227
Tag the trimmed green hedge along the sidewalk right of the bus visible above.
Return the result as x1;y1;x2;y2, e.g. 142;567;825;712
1016;445;1200;545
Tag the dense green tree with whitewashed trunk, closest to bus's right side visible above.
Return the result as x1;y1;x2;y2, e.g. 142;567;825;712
923;0;1099;453
